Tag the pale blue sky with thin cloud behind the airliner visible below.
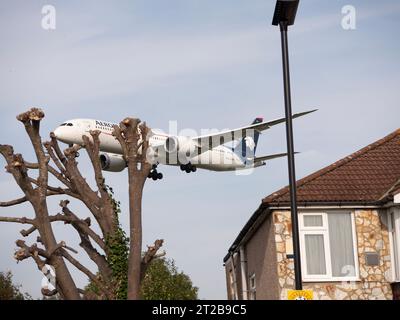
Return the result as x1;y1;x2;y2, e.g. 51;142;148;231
0;0;400;299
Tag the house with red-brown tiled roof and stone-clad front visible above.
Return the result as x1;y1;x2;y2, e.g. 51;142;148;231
224;129;400;300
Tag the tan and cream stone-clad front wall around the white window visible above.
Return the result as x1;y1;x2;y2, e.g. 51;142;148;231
273;210;392;300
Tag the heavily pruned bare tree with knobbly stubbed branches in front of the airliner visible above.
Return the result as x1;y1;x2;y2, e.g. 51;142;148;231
0;108;163;299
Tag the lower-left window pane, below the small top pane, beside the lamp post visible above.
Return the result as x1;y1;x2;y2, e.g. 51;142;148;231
305;234;326;275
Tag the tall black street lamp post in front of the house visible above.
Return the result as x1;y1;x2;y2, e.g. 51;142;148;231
272;0;303;290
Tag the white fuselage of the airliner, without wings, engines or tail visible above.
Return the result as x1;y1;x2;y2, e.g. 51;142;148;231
54;119;246;171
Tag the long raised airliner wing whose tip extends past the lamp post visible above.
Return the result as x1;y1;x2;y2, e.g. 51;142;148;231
192;109;317;154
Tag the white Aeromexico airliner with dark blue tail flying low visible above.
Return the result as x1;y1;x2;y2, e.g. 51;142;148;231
54;109;317;180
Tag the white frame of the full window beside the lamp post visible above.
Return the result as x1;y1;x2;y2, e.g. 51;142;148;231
299;211;360;282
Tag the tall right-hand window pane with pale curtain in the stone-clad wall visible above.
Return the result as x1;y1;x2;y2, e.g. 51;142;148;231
328;212;355;277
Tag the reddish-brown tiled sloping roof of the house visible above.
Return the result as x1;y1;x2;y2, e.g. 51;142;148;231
263;129;400;204
